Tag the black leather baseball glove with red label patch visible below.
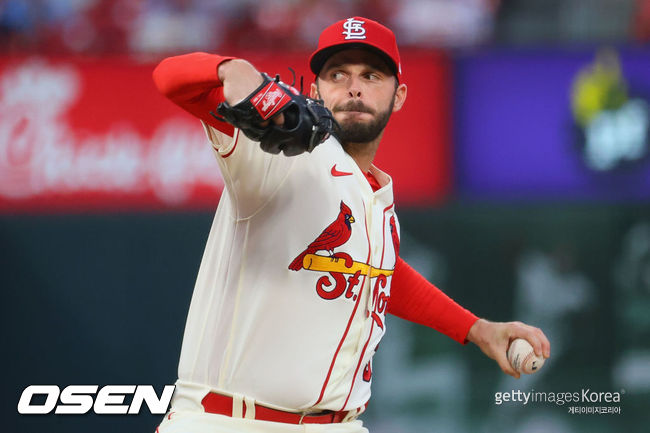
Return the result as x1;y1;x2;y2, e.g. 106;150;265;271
210;73;338;156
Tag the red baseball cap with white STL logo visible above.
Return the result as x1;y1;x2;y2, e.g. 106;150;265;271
309;17;402;81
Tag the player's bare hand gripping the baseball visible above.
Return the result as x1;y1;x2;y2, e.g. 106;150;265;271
467;319;551;379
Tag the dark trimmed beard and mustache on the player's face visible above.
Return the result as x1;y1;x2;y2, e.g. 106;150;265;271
334;95;395;146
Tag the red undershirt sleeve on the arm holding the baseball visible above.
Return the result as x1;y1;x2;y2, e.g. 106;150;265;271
387;257;478;344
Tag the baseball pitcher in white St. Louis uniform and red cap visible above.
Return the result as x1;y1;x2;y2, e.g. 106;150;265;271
154;17;550;433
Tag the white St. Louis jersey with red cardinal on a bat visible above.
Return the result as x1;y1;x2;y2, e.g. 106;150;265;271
172;120;399;412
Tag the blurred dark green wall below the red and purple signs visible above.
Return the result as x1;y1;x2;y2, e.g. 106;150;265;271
5;203;650;432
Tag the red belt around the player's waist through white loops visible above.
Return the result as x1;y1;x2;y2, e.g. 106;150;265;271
201;392;349;424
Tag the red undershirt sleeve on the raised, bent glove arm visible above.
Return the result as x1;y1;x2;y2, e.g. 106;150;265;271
153;53;234;136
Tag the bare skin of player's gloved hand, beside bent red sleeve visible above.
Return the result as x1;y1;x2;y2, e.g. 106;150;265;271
217;59;284;126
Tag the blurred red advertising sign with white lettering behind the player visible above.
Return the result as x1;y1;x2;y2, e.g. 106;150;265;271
0;53;450;213
